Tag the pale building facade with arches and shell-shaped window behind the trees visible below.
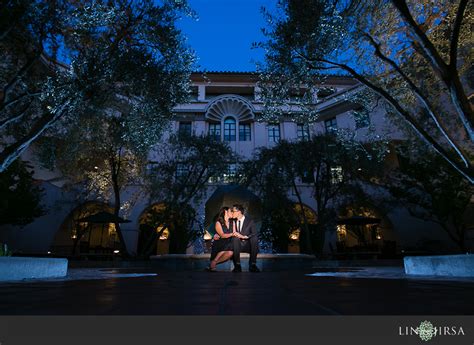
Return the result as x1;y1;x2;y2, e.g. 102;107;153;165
0;72;466;255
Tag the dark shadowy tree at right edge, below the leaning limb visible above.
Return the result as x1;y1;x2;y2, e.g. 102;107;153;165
383;141;474;252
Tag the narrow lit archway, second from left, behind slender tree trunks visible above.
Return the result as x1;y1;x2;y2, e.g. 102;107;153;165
137;203;170;255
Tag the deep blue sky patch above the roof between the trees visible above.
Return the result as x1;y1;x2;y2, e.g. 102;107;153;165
178;0;277;71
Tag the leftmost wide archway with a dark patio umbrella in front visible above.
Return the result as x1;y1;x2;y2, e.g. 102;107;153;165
50;201;120;255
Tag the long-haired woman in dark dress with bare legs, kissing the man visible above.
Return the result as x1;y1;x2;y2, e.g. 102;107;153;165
207;206;244;272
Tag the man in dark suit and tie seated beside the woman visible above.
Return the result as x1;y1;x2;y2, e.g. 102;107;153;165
232;204;260;272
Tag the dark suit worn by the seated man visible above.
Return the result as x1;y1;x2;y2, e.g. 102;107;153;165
232;216;258;267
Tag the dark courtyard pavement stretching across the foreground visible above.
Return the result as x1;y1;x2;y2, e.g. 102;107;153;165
0;267;474;315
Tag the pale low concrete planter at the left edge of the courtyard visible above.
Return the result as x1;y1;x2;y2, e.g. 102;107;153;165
0;256;68;281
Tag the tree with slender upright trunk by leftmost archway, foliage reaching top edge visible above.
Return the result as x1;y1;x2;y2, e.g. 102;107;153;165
31;0;193;255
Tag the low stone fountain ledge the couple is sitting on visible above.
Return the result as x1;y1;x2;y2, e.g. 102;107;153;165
150;253;315;271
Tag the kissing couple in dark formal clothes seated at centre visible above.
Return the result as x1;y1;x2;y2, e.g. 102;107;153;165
207;204;260;272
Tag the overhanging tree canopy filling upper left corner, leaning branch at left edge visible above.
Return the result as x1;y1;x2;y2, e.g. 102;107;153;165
0;0;194;171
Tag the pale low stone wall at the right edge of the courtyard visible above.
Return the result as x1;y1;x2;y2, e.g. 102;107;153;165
404;254;474;277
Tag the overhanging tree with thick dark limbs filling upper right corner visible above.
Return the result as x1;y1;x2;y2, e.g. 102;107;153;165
262;0;474;183
